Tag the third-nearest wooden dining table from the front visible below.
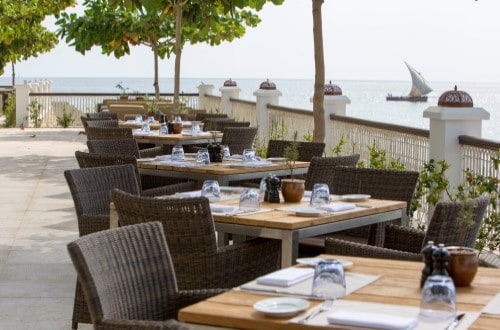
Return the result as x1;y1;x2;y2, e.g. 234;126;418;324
137;159;309;186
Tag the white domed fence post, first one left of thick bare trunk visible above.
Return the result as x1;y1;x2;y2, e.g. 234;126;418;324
253;81;282;144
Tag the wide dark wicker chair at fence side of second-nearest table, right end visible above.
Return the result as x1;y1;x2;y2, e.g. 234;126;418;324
300;166;419;255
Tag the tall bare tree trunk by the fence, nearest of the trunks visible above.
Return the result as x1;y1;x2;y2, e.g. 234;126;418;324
312;0;325;142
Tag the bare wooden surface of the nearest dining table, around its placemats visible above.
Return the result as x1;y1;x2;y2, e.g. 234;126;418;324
178;255;500;330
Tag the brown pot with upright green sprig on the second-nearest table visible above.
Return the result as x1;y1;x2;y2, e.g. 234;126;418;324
281;131;305;203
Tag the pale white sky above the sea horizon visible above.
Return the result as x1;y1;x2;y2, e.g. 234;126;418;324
2;0;500;82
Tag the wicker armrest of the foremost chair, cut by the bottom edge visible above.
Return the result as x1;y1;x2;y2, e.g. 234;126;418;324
95;320;194;330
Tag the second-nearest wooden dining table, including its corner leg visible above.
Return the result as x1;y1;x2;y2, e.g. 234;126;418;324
212;198;406;268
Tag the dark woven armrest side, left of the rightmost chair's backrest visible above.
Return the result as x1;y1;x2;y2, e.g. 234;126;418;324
383;225;425;254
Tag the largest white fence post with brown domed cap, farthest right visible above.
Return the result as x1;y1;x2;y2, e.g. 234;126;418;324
424;87;490;188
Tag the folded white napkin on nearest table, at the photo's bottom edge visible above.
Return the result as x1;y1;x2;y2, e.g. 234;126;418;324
328;309;417;330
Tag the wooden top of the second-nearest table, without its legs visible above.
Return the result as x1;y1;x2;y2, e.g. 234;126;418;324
213;198;406;230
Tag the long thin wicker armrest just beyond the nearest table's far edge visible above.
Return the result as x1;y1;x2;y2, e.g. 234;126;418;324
325;237;422;261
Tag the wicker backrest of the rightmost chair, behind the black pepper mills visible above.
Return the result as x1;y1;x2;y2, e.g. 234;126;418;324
423;195;489;248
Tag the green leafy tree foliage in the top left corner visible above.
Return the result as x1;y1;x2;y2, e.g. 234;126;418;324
0;0;75;83
